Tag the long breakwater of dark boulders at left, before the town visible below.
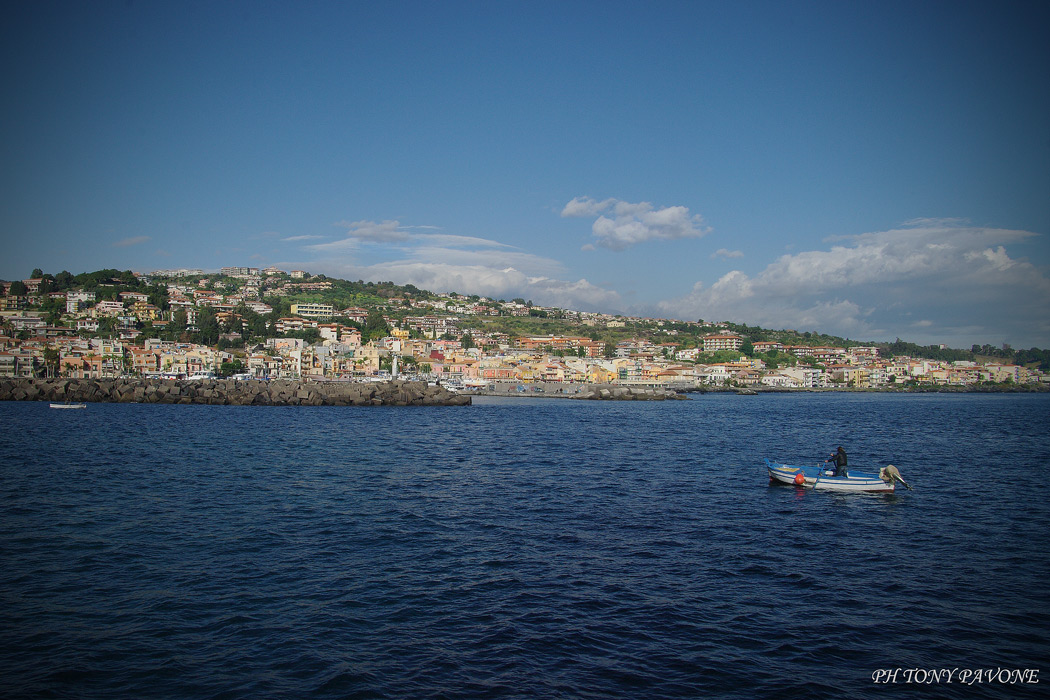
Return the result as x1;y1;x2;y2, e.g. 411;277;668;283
0;379;470;406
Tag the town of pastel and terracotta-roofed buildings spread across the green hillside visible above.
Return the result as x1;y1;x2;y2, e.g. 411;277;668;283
0;268;1050;391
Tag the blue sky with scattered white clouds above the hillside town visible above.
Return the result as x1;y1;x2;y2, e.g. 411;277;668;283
0;1;1050;347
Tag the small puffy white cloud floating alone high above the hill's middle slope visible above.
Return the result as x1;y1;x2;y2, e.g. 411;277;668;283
562;197;710;251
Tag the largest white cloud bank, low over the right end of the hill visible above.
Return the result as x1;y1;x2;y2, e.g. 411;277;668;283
659;219;1050;346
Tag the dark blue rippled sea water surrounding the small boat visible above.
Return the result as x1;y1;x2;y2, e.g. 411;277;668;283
0;394;1050;698
